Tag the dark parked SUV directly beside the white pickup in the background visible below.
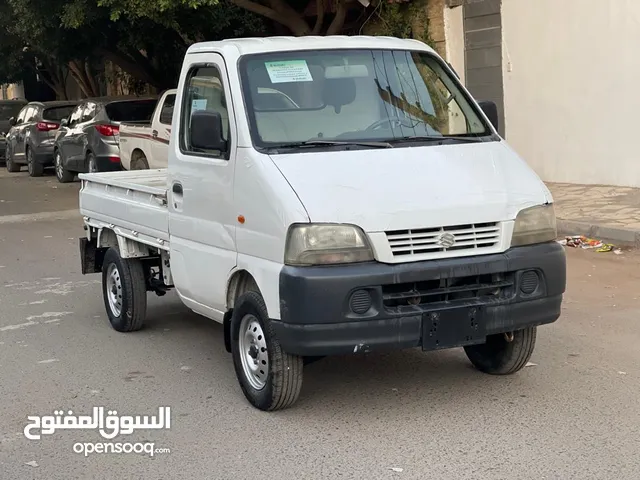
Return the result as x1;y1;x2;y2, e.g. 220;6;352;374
54;97;158;183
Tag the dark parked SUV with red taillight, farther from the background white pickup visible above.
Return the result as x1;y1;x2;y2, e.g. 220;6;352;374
6;101;78;177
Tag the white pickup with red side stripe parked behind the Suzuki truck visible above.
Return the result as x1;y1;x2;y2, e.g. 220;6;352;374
119;89;177;170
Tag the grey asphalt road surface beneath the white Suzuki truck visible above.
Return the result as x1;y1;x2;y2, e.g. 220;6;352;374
0;167;640;480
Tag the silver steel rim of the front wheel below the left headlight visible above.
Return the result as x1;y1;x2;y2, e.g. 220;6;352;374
238;314;269;390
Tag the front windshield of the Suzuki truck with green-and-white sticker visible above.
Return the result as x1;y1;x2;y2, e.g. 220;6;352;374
240;50;491;147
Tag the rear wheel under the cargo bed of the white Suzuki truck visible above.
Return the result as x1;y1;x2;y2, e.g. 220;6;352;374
102;248;147;332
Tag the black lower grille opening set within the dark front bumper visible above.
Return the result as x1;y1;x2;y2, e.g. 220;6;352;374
382;273;514;310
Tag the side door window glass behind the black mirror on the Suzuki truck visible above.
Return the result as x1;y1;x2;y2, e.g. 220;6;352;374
180;66;229;158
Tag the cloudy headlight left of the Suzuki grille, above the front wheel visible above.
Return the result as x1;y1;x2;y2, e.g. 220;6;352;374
284;223;373;265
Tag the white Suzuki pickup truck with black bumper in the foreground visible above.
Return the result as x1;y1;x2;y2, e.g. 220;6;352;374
80;36;566;410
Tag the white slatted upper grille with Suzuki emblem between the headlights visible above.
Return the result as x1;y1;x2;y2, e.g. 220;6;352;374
386;222;500;258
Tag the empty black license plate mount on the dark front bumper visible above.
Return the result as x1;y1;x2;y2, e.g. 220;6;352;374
422;307;487;350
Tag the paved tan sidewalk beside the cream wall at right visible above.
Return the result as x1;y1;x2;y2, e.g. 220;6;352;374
547;183;640;247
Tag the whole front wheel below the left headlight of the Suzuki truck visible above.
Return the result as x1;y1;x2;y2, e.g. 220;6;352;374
231;292;303;411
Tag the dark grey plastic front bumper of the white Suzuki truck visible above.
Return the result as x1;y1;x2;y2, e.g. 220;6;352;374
272;242;566;356
